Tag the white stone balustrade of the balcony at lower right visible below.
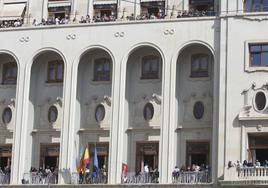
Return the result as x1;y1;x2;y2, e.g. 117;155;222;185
237;167;268;180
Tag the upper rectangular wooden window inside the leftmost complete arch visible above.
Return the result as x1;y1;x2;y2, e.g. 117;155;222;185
47;60;64;82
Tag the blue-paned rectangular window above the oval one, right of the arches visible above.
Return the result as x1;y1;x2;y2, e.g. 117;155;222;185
249;44;268;67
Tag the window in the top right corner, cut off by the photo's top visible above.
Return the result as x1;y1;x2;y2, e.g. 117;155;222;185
244;0;268;12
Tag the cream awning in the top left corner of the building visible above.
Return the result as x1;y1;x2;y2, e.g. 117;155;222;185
0;3;26;20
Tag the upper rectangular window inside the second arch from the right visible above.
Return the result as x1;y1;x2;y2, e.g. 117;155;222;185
141;56;159;79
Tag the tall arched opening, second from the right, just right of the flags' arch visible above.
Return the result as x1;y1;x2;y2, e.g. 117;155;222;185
123;45;163;179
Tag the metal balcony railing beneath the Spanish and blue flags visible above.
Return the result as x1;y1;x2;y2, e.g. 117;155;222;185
71;172;108;184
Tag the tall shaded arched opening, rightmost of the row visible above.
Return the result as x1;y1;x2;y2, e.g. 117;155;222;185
174;43;214;183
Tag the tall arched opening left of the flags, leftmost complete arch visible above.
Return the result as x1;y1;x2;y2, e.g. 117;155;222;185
25;50;65;184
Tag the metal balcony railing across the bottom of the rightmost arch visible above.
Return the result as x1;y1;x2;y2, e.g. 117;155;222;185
172;171;211;184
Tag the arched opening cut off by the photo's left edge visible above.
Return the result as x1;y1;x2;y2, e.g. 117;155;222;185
0;52;18;184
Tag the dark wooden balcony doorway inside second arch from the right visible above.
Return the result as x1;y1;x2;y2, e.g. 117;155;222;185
136;142;159;173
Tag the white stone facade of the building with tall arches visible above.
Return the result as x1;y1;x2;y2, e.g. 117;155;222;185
0;0;268;186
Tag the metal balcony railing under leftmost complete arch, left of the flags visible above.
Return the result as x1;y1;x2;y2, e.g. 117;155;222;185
22;173;58;184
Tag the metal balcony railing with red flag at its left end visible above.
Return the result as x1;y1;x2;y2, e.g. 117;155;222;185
121;172;159;184
